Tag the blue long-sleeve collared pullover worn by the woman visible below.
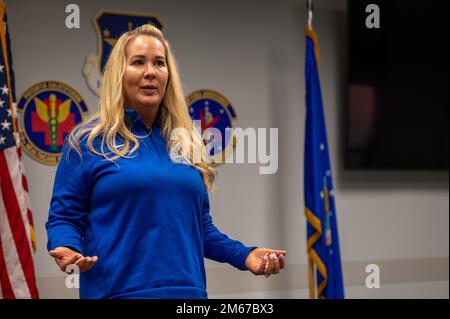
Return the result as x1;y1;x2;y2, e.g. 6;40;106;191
46;109;255;298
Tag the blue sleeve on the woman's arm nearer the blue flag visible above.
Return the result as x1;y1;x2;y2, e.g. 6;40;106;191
202;191;256;270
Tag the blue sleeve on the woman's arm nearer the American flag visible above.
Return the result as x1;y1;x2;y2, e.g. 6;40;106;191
45;143;92;255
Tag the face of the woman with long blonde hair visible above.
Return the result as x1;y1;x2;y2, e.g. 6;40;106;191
123;35;169;109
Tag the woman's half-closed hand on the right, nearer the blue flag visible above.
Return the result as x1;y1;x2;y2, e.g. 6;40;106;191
245;248;287;278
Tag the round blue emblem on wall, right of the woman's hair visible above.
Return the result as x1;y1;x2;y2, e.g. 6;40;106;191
186;90;237;165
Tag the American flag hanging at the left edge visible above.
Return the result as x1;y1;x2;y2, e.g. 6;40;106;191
0;3;39;299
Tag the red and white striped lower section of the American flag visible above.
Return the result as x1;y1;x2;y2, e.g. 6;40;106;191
0;147;39;299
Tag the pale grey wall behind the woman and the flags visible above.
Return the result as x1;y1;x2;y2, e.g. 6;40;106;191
8;0;449;298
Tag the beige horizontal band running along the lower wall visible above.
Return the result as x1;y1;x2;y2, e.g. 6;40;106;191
37;257;449;299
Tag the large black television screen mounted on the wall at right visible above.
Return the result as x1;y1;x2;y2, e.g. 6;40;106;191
344;0;449;170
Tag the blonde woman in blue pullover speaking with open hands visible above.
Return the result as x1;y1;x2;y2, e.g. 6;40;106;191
46;25;286;298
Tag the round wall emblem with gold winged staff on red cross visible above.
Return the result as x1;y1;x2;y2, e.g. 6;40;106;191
17;81;88;165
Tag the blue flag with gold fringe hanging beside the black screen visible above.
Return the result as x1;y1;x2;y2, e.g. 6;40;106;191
304;27;344;299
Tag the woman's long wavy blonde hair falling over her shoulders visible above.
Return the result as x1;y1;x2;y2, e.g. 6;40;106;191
68;24;216;191
